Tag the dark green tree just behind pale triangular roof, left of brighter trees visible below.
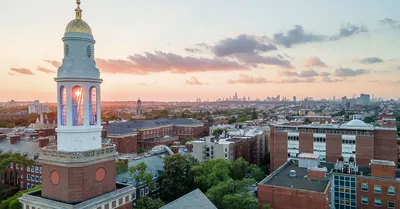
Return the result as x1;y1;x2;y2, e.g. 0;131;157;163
161;154;199;202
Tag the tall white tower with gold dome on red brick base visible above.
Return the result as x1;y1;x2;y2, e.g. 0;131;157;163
19;0;135;209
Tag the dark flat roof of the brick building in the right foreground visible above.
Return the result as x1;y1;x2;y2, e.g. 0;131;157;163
263;162;329;192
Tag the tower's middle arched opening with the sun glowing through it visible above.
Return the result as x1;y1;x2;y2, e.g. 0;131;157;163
72;86;84;126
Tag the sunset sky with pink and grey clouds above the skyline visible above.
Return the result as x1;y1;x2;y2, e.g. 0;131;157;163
0;0;400;102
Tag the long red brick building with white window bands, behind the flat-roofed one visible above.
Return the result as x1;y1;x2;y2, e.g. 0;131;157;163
270;120;398;170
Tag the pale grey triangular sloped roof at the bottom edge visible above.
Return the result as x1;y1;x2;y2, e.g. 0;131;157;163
160;189;217;209
